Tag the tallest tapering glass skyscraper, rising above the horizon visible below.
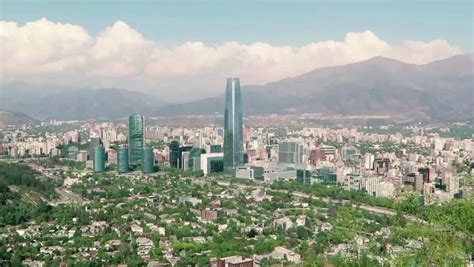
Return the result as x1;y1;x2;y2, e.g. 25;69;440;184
224;78;244;176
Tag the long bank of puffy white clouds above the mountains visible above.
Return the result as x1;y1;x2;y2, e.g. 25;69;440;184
0;18;462;100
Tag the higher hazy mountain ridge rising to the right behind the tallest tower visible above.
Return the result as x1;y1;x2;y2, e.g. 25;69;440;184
159;55;474;120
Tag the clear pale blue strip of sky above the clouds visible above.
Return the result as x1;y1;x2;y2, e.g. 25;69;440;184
1;0;473;52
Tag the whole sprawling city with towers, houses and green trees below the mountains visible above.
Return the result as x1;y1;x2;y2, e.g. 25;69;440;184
0;78;474;267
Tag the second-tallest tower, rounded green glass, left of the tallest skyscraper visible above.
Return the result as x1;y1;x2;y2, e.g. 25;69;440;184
128;114;145;167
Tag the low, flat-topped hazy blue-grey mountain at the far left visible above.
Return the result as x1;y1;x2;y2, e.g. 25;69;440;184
0;84;163;119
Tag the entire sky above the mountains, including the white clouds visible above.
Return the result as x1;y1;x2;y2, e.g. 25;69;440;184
0;0;474;100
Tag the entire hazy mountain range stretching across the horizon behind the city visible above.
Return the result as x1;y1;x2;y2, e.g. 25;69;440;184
0;54;474;120
